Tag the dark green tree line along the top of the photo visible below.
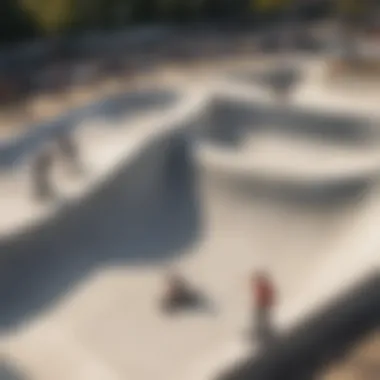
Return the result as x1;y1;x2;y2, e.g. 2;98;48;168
0;0;334;42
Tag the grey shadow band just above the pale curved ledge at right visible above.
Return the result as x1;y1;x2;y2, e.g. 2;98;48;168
204;98;378;146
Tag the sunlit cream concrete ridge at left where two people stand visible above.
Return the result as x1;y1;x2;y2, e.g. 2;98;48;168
0;85;208;238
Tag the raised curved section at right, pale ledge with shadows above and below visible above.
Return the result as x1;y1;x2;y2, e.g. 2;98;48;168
195;94;380;203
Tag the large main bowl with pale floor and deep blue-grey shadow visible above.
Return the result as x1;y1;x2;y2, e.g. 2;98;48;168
0;57;380;380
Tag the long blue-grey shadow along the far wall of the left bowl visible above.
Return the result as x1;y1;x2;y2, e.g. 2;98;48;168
0;88;178;170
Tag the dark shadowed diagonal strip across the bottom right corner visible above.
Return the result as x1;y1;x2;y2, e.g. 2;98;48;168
215;272;380;380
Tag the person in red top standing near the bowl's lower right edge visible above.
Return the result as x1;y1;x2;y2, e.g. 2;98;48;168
251;272;275;344
